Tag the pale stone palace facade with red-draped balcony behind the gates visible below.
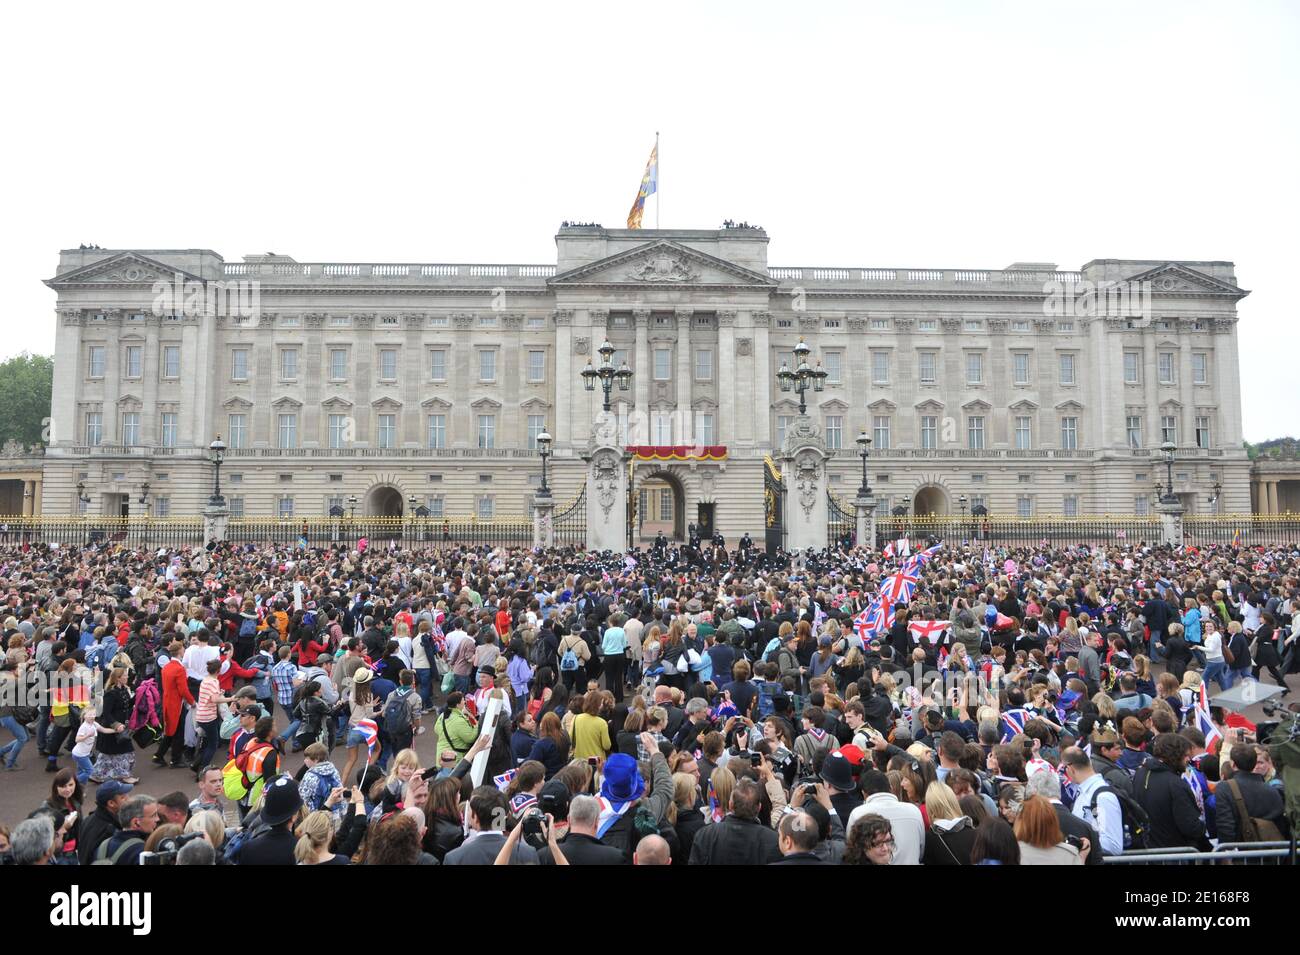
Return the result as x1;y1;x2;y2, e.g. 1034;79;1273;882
39;223;1251;539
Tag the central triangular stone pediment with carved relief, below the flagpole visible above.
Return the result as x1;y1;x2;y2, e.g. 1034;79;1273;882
547;239;776;288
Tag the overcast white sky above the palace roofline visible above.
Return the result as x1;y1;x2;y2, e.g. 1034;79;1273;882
0;0;1300;440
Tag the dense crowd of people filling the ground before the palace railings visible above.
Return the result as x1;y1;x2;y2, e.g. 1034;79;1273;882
0;539;1300;865
